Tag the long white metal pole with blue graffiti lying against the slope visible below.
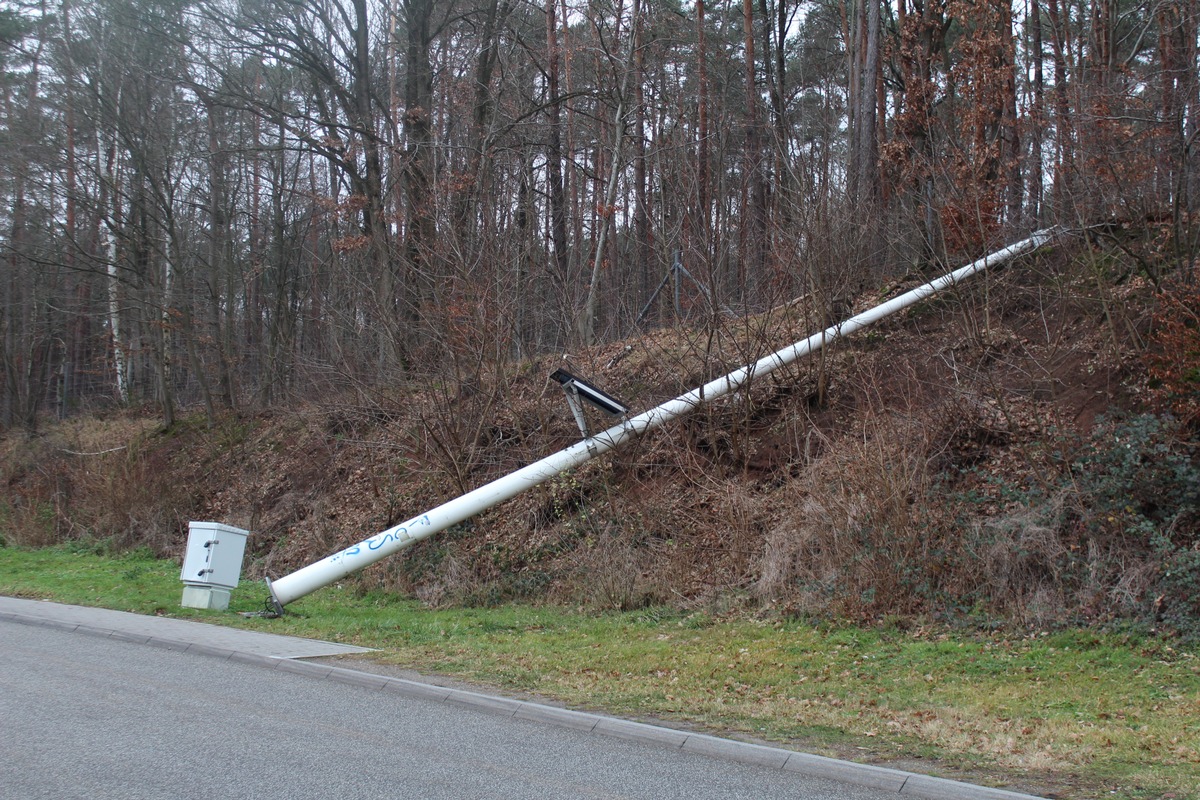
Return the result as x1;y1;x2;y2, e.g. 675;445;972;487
268;228;1057;610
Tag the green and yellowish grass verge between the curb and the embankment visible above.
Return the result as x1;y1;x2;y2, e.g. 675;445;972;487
0;545;1200;799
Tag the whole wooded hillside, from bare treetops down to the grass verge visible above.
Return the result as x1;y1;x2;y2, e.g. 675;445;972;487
0;0;1200;633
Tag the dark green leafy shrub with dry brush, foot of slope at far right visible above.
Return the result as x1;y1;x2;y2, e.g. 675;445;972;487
972;415;1200;634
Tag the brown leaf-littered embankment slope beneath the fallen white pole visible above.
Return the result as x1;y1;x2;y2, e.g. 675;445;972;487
5;237;1195;621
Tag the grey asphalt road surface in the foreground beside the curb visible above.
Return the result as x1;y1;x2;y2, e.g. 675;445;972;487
0;621;896;800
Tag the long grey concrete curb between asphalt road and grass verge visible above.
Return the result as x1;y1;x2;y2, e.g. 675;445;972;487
0;612;1044;800
